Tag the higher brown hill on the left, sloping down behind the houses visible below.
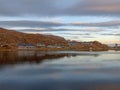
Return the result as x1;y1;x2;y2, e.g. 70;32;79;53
0;28;67;48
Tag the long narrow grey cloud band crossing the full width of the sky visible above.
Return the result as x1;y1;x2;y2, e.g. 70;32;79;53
0;20;120;30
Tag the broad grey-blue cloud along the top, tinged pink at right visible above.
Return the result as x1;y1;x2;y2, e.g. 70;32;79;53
0;0;120;17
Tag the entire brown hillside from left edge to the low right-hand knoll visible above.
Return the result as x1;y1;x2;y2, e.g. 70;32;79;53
0;28;110;51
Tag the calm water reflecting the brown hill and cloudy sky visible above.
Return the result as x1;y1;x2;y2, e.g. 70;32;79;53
0;51;120;90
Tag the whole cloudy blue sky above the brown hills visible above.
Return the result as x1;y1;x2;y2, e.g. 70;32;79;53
0;0;120;44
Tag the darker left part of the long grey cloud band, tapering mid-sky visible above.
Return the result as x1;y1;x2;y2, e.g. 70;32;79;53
0;20;64;27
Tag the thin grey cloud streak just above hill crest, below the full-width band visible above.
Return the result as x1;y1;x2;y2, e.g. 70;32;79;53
16;28;102;35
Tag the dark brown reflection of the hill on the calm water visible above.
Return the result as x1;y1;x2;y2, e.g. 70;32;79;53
0;51;98;65
